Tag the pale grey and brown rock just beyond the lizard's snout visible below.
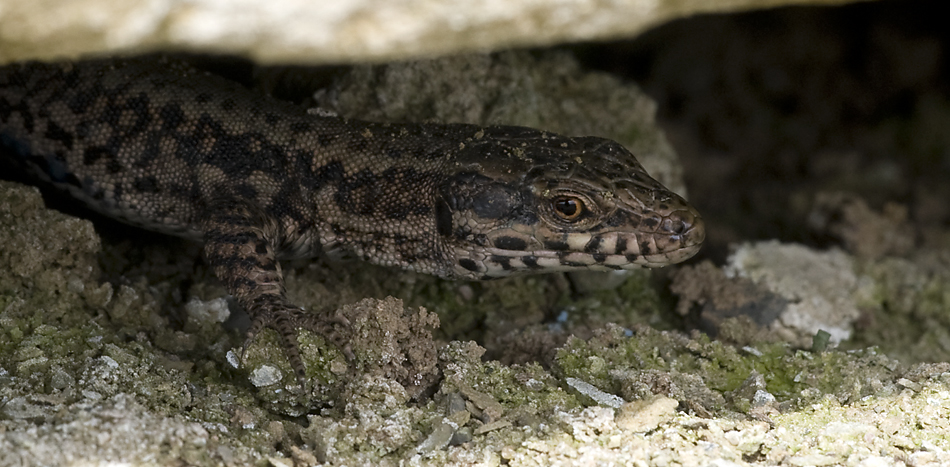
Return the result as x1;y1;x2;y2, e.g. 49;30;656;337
671;241;873;348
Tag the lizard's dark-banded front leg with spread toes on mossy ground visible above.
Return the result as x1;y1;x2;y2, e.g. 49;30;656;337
202;200;350;387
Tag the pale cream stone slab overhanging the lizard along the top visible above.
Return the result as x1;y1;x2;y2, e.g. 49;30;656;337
0;0;868;63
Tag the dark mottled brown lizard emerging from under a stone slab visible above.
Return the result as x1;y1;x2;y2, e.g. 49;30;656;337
0;57;705;385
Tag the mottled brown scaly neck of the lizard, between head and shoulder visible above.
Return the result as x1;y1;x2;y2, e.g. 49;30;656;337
297;119;462;277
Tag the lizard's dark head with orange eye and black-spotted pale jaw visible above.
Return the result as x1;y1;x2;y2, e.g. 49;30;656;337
436;127;705;279
